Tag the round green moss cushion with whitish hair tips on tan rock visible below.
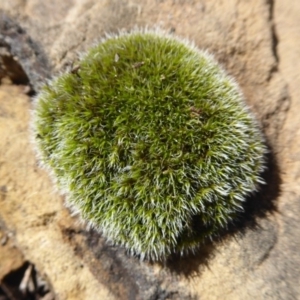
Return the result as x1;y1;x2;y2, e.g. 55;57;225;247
33;31;265;259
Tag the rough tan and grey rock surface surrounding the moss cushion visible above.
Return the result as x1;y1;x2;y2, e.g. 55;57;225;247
0;0;300;300
